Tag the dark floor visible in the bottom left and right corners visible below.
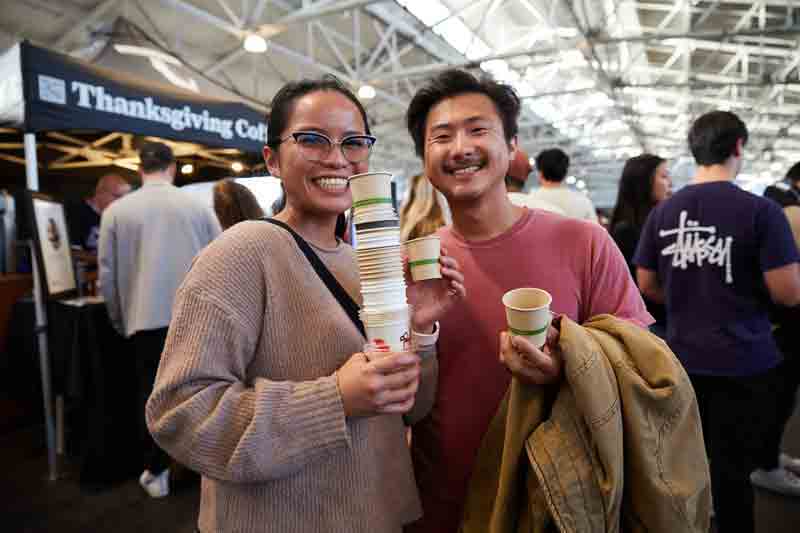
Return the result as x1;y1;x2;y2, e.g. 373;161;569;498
0;390;800;533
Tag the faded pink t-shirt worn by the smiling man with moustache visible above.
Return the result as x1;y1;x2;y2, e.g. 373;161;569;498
406;209;653;533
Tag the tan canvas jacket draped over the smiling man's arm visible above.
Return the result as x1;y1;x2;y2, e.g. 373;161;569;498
462;315;711;533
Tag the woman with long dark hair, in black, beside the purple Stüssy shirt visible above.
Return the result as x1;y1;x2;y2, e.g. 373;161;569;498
608;154;672;337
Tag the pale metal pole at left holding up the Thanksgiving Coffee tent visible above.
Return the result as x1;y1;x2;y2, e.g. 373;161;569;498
25;133;58;481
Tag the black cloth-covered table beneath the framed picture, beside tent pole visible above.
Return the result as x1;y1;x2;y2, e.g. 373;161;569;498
48;298;138;486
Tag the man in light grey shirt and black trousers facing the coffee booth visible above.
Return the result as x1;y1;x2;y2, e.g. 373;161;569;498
98;142;221;498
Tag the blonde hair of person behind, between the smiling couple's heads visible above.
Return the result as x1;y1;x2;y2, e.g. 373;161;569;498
400;174;447;241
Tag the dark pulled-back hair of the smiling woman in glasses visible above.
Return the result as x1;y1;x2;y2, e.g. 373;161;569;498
267;75;370;150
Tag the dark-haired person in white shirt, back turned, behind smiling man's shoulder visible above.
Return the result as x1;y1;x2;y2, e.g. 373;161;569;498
530;148;598;222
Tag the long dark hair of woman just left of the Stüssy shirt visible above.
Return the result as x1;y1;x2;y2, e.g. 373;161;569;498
608;154;666;229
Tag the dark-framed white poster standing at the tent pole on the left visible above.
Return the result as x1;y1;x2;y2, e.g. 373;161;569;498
28;191;78;299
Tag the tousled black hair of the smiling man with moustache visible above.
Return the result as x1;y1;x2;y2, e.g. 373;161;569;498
406;70;520;158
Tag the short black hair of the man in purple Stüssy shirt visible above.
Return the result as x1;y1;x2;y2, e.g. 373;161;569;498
689;111;748;166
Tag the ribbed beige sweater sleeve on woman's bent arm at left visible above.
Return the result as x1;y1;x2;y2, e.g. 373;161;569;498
147;291;349;482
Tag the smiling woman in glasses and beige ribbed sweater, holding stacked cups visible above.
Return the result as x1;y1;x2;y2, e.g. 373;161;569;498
147;79;464;533
